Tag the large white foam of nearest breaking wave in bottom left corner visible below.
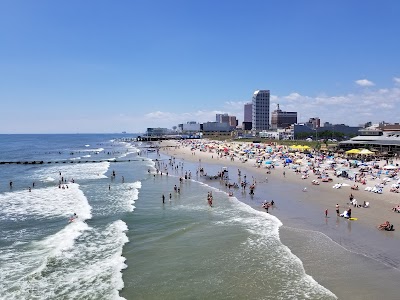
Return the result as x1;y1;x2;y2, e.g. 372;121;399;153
0;220;129;300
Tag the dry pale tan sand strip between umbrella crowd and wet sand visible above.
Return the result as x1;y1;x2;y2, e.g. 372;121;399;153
162;141;400;233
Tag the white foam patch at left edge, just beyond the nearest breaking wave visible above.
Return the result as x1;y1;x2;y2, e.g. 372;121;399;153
0;183;91;221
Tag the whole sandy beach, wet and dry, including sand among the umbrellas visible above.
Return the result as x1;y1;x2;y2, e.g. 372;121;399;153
160;141;400;299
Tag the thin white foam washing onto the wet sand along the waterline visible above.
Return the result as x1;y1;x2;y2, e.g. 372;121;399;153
186;178;336;299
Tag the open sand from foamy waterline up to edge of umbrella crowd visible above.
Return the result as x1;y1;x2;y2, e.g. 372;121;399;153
160;141;400;299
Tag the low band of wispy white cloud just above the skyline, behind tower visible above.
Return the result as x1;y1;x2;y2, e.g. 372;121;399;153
143;77;400;127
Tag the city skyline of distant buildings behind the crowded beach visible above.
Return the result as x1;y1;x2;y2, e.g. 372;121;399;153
147;90;400;139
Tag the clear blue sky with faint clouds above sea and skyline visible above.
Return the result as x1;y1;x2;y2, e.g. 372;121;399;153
0;0;400;133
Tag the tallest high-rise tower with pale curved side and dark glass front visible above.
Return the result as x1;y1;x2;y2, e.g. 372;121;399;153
252;90;269;131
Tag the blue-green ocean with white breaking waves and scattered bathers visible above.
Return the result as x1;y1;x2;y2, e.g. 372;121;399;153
0;134;337;300
